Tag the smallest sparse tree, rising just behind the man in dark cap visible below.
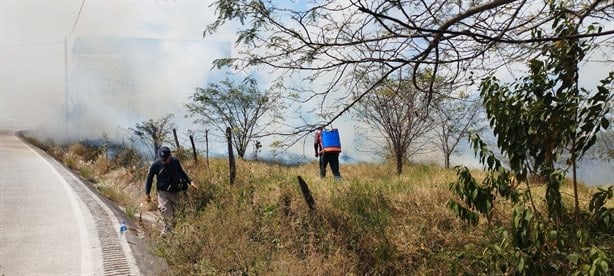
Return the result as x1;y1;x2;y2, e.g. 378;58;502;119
129;114;175;159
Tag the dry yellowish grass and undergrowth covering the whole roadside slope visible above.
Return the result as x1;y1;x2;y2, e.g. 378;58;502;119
21;139;614;275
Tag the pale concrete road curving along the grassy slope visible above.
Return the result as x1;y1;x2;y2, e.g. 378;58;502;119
0;130;140;276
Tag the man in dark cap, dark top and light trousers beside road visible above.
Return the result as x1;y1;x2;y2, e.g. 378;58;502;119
145;147;198;235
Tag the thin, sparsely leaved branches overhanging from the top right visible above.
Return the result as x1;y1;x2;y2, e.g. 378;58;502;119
204;0;614;134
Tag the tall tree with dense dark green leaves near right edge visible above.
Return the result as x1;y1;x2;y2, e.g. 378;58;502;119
481;18;614;219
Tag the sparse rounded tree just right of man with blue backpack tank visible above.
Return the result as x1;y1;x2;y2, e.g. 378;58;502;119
355;75;432;175
